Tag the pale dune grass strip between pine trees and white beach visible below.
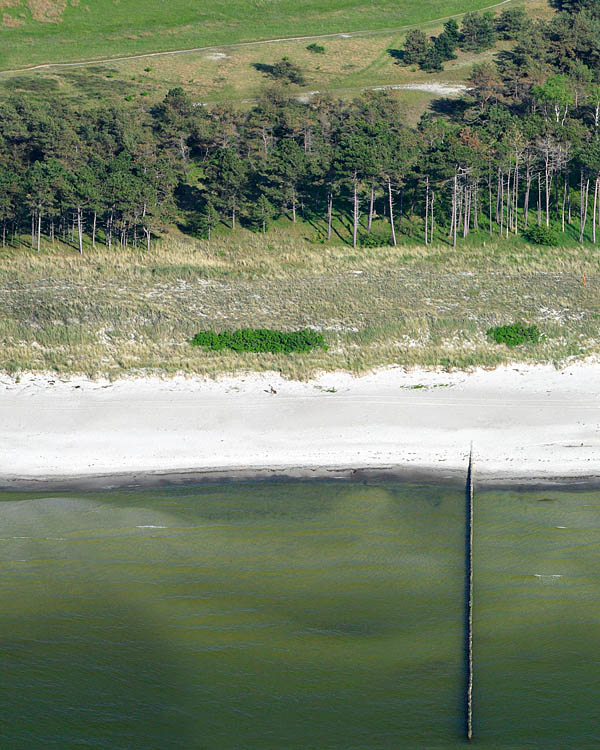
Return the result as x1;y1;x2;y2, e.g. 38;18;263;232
0;229;600;378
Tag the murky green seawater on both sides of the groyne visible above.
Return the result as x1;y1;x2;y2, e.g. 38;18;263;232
0;481;600;750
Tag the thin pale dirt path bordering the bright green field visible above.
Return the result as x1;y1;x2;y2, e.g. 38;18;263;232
0;0;515;74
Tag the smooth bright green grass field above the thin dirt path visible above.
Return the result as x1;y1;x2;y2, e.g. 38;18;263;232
0;0;516;70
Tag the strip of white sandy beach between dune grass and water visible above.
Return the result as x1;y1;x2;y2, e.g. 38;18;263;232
0;362;600;485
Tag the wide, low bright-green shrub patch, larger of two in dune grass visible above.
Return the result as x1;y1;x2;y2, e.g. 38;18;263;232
191;328;327;354
